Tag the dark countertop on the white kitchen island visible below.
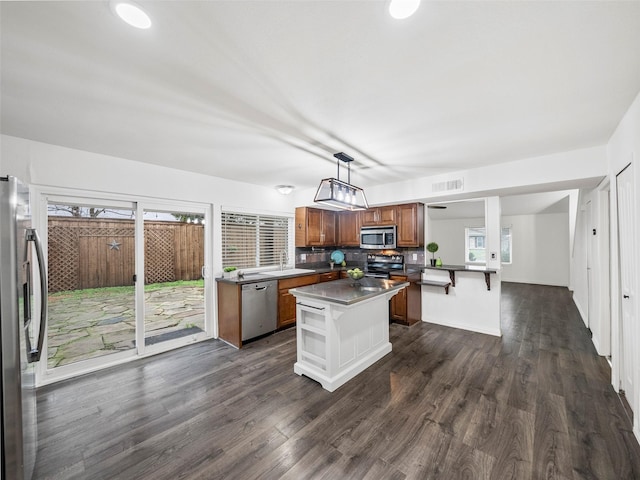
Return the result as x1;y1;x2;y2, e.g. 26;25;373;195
289;277;409;305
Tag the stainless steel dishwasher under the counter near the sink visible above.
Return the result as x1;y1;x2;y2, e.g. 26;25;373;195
242;280;278;342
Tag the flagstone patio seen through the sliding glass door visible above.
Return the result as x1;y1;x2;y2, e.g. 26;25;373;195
47;285;204;368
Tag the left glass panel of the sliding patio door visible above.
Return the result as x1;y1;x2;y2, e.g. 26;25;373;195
46;198;136;369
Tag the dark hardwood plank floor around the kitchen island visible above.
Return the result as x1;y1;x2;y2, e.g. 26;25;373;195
36;283;640;480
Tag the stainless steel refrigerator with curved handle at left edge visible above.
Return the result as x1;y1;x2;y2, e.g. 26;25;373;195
0;176;47;480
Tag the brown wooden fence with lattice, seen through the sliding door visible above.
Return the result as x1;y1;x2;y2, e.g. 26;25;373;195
48;217;204;293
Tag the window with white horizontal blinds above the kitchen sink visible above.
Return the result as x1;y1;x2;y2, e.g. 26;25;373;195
222;212;291;268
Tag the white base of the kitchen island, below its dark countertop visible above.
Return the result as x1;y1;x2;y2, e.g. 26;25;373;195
291;284;406;392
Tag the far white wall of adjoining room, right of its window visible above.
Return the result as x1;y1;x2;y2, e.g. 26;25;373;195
501;213;569;287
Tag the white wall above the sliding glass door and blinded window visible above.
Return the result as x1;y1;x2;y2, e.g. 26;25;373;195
0;135;295;272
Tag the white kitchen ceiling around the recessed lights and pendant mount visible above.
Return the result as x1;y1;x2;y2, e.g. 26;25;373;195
0;0;640;194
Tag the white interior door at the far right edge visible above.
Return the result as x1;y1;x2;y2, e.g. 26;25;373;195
616;164;638;408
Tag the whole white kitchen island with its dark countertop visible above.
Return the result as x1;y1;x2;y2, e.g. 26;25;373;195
290;278;409;392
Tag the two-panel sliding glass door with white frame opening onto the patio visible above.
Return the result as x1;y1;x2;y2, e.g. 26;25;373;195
39;195;213;383
